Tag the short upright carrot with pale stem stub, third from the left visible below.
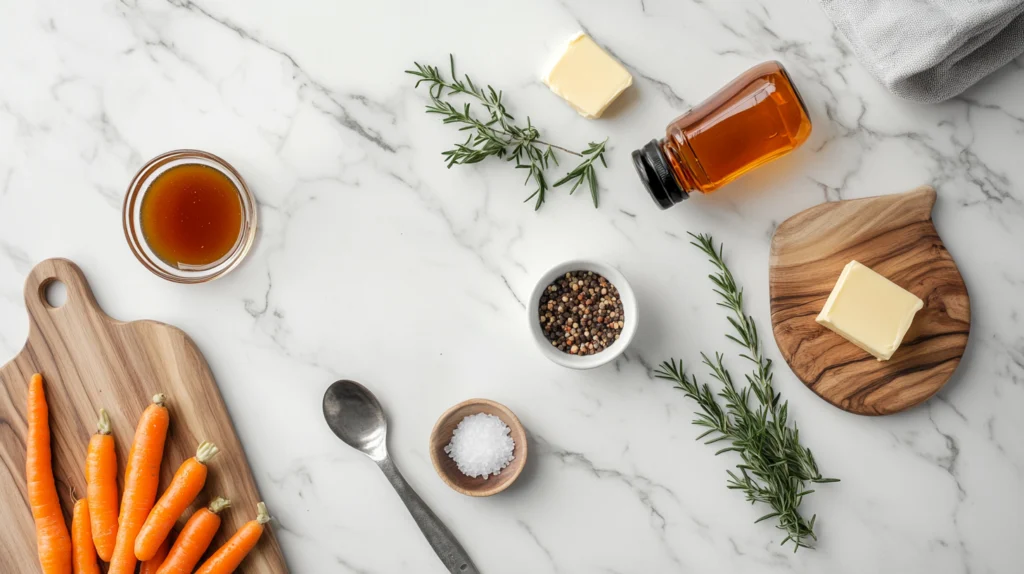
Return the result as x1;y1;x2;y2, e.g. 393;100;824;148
85;408;118;562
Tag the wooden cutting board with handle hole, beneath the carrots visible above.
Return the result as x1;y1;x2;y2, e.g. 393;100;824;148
0;259;288;574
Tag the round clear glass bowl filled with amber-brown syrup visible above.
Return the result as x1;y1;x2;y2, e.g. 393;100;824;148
124;149;256;282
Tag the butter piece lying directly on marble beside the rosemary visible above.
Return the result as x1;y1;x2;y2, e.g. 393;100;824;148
544;32;633;119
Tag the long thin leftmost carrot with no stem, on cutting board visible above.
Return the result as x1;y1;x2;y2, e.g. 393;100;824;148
25;373;72;574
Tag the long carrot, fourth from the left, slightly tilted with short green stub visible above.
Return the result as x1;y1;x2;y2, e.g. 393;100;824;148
106;395;170;574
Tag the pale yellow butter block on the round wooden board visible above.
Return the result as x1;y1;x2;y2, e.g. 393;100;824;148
815;261;925;361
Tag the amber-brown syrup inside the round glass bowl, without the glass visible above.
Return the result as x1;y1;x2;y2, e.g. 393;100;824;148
139;164;243;269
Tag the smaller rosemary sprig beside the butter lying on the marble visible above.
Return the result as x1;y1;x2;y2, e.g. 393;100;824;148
406;54;608;210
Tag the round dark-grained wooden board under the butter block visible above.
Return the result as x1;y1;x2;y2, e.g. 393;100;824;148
768;186;971;414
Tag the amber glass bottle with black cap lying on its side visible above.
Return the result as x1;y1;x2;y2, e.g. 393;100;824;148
633;61;811;209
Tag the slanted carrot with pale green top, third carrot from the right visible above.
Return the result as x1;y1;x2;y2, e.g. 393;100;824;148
135;441;217;560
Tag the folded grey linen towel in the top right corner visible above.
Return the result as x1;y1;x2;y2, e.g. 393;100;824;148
821;0;1024;103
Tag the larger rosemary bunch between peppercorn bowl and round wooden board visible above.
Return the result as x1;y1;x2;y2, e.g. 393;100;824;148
655;233;839;551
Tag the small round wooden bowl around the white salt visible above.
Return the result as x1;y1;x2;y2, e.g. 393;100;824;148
430;399;526;496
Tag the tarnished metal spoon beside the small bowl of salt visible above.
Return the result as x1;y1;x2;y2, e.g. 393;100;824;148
324;381;479;574
